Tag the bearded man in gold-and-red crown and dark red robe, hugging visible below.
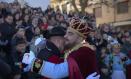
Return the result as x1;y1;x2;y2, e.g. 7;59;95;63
23;18;100;79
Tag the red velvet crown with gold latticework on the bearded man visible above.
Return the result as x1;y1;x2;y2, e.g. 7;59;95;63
69;18;92;38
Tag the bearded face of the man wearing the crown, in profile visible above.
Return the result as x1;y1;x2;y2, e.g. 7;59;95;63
64;28;80;48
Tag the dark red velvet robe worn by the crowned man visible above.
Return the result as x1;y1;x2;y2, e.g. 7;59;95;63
67;47;98;79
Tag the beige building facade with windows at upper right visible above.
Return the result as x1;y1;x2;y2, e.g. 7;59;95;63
88;0;131;29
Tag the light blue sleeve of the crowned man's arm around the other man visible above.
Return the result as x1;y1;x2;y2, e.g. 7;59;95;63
39;61;69;79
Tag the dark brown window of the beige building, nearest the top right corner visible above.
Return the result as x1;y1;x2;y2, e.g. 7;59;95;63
117;1;128;14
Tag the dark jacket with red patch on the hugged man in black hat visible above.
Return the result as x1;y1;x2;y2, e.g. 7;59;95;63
37;41;63;63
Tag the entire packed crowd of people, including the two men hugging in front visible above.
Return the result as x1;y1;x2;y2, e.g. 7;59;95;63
0;2;131;79
